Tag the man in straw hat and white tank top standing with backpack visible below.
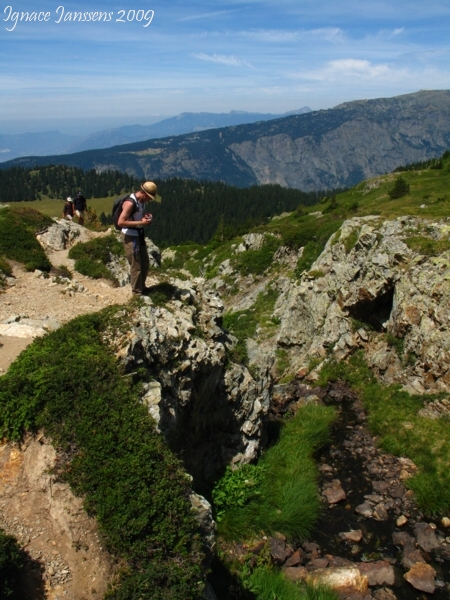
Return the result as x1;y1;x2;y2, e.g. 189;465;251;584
117;181;158;296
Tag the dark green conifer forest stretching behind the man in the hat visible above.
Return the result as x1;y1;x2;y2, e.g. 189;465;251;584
0;165;342;245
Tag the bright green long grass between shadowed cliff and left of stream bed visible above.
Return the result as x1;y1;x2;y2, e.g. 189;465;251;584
219;405;335;539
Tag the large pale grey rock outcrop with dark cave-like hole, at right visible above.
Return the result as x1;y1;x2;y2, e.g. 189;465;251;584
275;217;450;393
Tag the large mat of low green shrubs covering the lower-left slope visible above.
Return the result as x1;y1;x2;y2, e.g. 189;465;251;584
0;310;204;600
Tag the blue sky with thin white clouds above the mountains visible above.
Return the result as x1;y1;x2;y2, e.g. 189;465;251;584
0;0;450;133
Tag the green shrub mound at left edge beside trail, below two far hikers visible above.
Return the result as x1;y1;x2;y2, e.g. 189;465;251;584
0;207;53;272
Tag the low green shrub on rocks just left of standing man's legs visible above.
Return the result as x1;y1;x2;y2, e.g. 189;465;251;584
69;234;125;281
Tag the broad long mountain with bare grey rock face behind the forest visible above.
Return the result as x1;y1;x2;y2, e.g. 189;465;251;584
4;90;450;191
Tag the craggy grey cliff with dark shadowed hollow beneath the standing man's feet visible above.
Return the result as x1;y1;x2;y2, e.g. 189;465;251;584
106;279;270;491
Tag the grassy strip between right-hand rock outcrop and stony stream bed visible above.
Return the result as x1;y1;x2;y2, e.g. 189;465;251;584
319;352;450;517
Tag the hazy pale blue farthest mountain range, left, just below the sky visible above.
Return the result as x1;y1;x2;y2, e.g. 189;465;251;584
0;106;311;162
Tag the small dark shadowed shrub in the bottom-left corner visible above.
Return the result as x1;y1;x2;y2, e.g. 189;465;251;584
0;529;26;600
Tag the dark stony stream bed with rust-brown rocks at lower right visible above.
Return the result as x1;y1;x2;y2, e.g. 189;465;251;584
219;382;450;600
